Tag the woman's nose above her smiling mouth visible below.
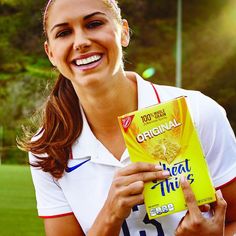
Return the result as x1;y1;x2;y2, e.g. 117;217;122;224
73;30;91;52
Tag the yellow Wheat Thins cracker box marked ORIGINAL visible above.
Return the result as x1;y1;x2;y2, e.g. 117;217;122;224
118;97;215;219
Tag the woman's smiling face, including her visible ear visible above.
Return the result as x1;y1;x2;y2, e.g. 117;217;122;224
45;0;129;86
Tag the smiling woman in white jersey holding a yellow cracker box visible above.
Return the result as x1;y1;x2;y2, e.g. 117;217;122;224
20;0;236;236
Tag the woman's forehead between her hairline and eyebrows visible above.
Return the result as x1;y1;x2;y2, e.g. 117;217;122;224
47;0;111;26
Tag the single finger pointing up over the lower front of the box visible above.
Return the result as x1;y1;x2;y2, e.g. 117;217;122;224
180;176;201;216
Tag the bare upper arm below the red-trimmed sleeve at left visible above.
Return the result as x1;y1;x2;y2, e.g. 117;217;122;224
44;214;85;236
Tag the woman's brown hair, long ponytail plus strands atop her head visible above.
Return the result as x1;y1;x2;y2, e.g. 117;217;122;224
17;0;121;179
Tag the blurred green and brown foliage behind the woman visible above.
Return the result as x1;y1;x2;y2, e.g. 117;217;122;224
0;0;236;163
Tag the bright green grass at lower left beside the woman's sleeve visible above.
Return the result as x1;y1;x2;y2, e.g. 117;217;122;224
0;165;45;236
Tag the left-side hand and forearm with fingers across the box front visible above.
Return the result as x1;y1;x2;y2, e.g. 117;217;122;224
88;162;170;236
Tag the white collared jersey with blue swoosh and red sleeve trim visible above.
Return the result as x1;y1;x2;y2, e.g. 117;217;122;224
30;75;236;236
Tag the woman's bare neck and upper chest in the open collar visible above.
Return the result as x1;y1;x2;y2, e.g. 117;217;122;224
73;71;138;159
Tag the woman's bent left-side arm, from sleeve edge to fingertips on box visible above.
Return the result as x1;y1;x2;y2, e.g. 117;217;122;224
44;163;170;236
